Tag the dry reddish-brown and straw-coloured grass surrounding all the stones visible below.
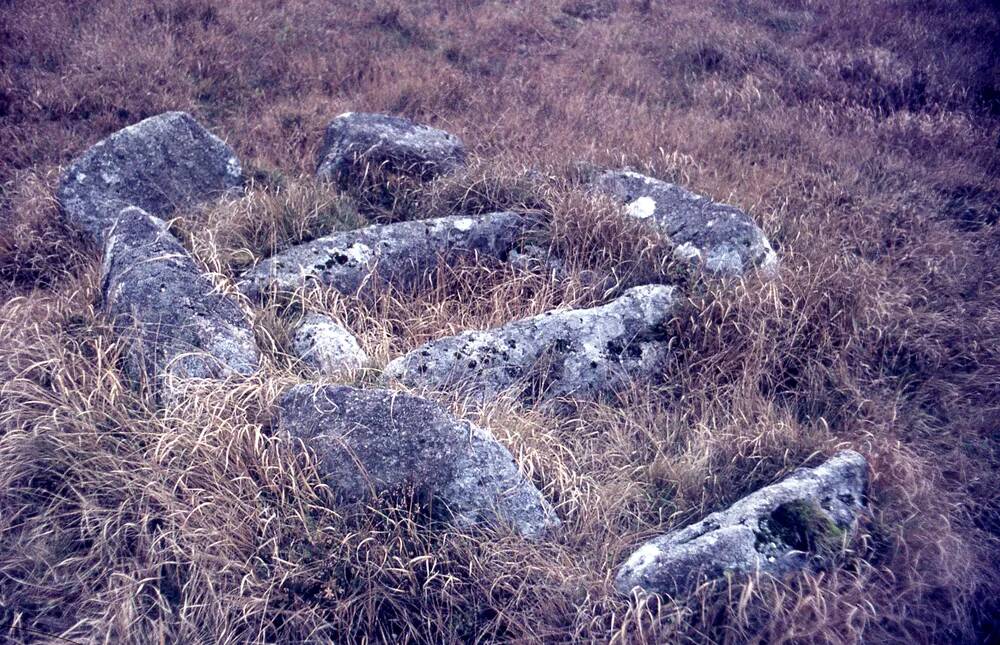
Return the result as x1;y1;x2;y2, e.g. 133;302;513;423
0;0;1000;642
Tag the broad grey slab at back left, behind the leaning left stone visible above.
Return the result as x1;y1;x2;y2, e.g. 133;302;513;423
58;112;243;243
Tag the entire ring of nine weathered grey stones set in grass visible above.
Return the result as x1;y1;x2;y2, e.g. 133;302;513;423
58;112;867;596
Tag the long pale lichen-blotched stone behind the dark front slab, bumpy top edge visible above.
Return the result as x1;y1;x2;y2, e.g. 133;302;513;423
383;285;679;401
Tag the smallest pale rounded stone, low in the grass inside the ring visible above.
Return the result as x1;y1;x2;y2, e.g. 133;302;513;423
292;314;368;378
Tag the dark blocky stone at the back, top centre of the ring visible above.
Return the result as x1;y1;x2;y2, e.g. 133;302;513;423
316;112;465;185
